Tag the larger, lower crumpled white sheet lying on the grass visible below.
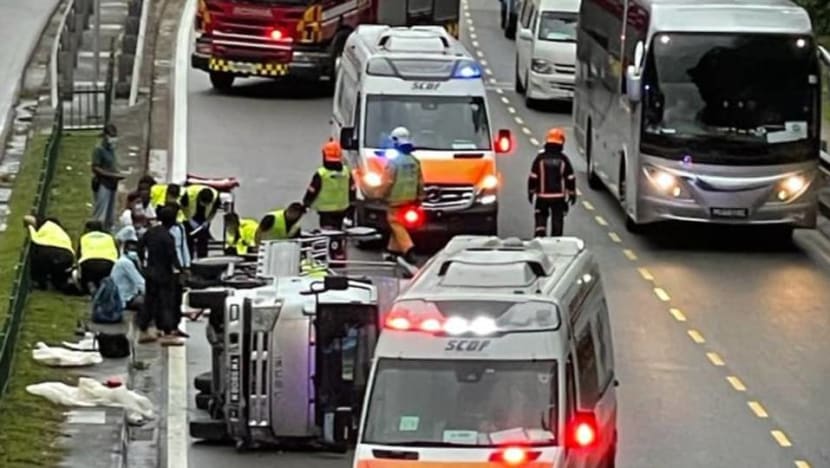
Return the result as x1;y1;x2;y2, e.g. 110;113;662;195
26;377;154;422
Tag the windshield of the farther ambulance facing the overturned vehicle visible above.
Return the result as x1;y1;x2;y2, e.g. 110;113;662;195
363;95;491;151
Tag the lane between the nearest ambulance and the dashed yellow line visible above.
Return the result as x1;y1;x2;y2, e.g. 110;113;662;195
491;89;791;468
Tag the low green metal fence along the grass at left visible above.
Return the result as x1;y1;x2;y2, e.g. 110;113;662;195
0;106;63;395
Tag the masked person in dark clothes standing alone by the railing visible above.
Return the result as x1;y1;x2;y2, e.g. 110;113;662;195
92;124;124;230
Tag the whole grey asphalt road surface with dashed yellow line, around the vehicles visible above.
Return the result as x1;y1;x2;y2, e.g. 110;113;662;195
182;0;830;468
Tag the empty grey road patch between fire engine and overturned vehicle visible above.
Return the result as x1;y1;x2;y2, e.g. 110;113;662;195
188;70;331;219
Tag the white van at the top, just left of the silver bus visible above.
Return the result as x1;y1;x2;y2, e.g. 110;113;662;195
516;0;580;107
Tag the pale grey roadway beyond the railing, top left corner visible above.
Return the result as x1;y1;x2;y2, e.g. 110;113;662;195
0;0;58;133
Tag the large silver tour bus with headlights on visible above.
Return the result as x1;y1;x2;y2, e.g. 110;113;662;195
574;0;821;232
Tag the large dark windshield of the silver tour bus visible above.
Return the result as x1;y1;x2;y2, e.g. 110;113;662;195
641;33;820;165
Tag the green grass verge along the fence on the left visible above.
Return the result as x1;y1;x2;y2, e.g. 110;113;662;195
0;134;98;468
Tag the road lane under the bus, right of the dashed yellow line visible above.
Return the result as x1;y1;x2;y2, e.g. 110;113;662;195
474;1;830;464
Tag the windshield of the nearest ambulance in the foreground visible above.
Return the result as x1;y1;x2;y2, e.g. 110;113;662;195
363;359;559;447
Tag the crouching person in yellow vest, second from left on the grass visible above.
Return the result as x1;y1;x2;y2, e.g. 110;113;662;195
78;221;118;294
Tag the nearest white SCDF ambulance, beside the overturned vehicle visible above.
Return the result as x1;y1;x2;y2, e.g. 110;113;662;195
354;236;617;468
